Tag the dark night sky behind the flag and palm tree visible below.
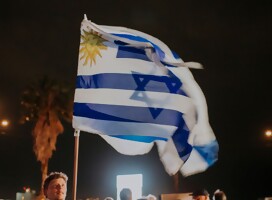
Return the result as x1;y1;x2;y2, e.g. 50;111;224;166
0;0;272;200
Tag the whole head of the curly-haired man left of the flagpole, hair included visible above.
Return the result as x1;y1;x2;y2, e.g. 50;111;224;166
43;172;68;200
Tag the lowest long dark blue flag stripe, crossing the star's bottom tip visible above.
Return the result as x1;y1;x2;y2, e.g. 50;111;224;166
74;102;185;127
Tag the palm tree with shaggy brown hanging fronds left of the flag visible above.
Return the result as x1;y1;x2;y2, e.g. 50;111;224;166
20;77;73;198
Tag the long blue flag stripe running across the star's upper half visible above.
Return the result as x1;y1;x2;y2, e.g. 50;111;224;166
76;73;187;96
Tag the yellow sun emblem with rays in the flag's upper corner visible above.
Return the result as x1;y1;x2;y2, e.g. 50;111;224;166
79;30;107;66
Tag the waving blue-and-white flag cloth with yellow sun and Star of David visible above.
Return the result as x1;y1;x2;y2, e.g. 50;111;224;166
73;17;218;176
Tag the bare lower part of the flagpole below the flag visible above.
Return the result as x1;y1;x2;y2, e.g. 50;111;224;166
73;129;80;200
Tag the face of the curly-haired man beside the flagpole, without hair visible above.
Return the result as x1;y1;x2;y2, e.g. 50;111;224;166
45;178;67;200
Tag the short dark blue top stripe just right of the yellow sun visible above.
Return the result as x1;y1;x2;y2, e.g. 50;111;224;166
116;46;150;61
